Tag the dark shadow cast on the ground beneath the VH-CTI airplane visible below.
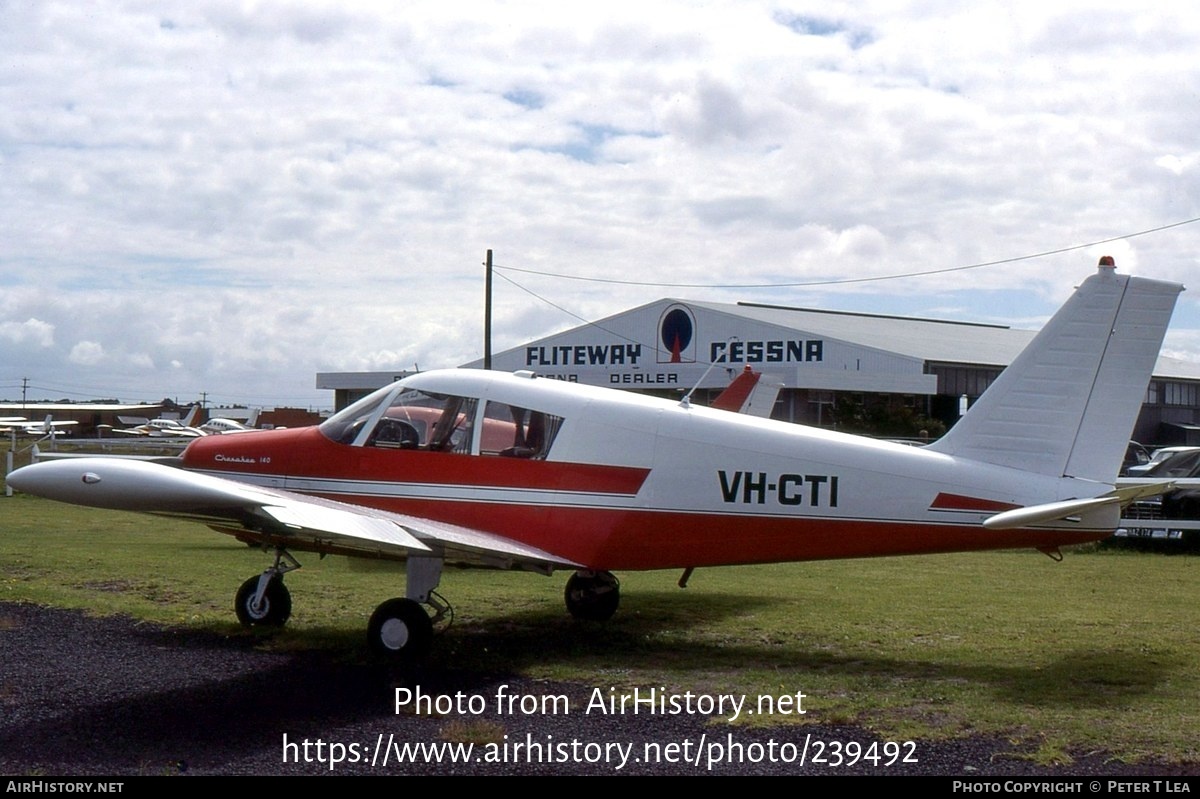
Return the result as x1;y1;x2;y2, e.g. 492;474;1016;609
248;583;1181;709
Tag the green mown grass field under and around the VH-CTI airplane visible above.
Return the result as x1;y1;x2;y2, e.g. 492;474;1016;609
0;495;1200;763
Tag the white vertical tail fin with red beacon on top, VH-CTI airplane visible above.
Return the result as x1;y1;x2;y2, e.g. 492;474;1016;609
929;257;1183;482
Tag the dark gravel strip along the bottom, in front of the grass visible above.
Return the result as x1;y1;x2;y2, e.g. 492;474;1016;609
0;603;1200;777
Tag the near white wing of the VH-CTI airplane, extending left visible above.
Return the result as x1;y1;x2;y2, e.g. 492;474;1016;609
8;457;580;572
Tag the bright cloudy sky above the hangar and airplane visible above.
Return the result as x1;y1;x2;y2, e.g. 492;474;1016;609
0;0;1200;407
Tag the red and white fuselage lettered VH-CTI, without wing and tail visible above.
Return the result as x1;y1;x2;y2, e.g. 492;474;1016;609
177;370;1115;570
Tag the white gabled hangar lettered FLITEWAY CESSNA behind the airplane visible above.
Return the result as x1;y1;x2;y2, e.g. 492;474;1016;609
318;299;1200;444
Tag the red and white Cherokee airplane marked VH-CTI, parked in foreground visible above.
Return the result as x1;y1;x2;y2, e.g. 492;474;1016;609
8;259;1182;654
